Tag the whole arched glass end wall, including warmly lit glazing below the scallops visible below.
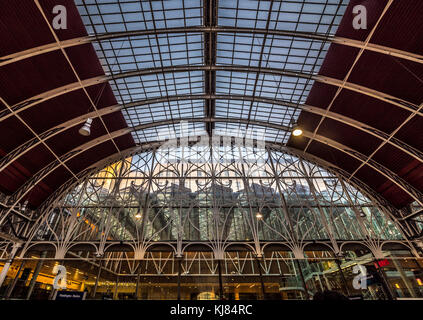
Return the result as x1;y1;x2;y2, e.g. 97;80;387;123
9;143;420;300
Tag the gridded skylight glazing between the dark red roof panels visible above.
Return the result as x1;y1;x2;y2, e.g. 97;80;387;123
75;0;349;144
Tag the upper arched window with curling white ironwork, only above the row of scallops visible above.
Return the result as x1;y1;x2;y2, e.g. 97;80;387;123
32;143;402;256
